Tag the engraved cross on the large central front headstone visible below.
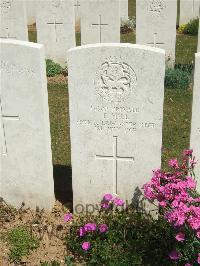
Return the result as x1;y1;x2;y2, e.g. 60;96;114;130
96;136;134;195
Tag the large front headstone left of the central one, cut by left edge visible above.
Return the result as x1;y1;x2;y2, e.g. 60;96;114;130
0;40;54;210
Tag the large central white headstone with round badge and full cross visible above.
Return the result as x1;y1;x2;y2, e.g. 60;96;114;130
68;44;165;214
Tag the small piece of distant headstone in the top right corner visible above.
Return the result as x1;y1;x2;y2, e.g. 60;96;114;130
179;0;200;25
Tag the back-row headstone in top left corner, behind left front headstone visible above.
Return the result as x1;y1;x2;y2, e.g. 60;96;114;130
0;0;28;41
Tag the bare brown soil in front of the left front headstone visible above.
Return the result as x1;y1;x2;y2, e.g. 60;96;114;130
0;199;73;266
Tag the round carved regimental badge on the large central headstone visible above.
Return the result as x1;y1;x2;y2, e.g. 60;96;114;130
95;58;137;102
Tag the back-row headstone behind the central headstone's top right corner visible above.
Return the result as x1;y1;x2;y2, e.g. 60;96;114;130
136;0;177;65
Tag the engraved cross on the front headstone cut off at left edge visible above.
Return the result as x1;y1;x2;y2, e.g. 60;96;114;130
0;98;19;155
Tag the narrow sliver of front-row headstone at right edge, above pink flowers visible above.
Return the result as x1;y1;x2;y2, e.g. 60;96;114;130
190;53;200;193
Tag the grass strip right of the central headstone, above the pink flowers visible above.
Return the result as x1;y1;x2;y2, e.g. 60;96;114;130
162;89;192;168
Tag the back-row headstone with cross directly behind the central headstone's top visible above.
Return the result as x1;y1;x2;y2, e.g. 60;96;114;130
81;0;120;45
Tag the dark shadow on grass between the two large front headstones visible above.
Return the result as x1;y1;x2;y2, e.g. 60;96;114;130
53;165;73;210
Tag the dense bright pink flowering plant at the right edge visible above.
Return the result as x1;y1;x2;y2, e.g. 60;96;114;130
143;150;200;266
